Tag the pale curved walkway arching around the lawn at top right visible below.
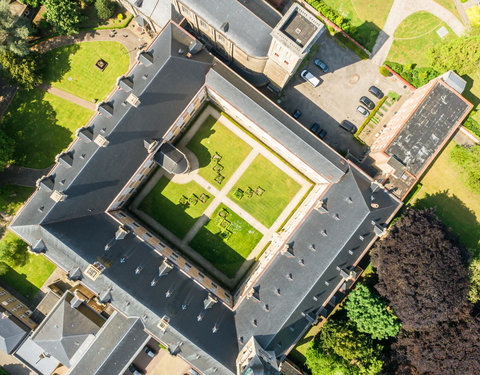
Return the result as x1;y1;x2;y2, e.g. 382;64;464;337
372;0;465;66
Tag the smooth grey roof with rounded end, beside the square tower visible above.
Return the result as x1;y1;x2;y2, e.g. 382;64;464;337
181;0;281;57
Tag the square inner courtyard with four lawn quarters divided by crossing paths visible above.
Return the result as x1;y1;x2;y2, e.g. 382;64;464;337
130;106;312;286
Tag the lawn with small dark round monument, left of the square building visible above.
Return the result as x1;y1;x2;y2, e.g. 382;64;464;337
43;42;129;101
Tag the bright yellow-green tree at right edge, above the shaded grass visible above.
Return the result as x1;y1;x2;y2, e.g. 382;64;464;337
450;145;480;193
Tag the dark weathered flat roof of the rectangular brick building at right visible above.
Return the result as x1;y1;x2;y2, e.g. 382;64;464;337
385;80;471;177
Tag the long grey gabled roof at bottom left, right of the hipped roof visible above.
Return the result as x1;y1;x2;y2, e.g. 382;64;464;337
68;312;150;375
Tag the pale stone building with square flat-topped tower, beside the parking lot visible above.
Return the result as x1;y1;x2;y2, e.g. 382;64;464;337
120;0;325;90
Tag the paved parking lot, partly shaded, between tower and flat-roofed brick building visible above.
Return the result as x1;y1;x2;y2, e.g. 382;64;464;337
280;35;410;158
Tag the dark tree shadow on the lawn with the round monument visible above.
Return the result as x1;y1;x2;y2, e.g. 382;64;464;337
42;44;80;83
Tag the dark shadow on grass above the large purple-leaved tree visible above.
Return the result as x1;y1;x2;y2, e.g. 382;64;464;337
414;190;480;258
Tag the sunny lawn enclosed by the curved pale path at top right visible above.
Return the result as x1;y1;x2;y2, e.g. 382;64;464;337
387;12;457;67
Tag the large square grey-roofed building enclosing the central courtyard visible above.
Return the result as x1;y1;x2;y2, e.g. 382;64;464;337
10;22;401;375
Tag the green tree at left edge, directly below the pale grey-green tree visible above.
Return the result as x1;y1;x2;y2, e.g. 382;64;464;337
0;51;42;90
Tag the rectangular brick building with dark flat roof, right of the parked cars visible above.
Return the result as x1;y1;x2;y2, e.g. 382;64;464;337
370;71;473;199
